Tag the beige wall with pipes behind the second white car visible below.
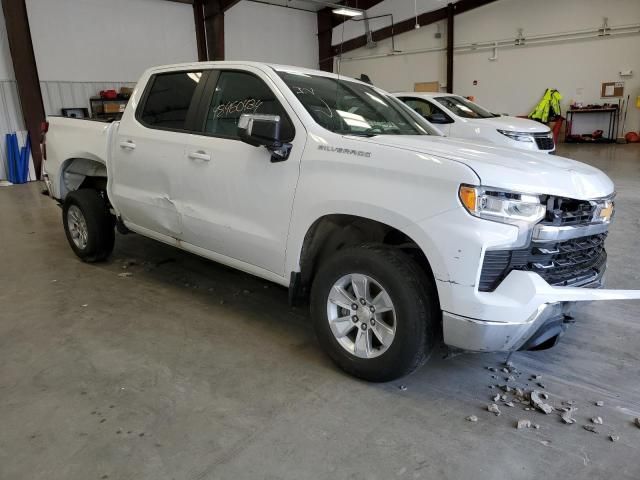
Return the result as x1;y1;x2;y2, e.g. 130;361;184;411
340;0;640;135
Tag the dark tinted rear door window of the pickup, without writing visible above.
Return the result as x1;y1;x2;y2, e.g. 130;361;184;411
138;71;204;130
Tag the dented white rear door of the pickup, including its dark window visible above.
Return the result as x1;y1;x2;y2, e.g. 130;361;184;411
110;71;206;240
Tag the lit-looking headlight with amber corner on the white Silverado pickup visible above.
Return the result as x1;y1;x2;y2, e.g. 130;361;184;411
459;185;547;224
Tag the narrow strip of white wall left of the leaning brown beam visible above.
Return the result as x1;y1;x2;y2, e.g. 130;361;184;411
0;4;26;180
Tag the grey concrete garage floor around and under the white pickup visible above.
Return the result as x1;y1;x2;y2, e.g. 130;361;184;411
0;145;640;480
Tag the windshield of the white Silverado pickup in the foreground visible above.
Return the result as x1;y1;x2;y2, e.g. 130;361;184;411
276;70;434;136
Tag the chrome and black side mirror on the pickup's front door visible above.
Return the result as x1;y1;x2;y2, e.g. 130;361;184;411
238;113;291;162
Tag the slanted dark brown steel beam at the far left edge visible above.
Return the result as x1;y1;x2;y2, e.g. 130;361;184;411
2;0;45;179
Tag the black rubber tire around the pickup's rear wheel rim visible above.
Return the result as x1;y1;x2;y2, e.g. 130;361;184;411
62;189;115;263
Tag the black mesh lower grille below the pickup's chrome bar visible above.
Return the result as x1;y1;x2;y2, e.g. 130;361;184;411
478;233;607;292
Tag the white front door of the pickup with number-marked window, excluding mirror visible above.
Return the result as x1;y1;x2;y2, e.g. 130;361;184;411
180;67;306;275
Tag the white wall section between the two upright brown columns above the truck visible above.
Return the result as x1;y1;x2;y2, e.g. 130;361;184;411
224;0;318;68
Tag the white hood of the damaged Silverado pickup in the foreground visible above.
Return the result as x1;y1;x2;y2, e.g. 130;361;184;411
349;135;614;200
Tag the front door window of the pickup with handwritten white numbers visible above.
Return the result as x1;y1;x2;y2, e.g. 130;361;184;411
205;71;294;142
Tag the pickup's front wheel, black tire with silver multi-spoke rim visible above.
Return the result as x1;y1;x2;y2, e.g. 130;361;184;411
311;245;439;382
